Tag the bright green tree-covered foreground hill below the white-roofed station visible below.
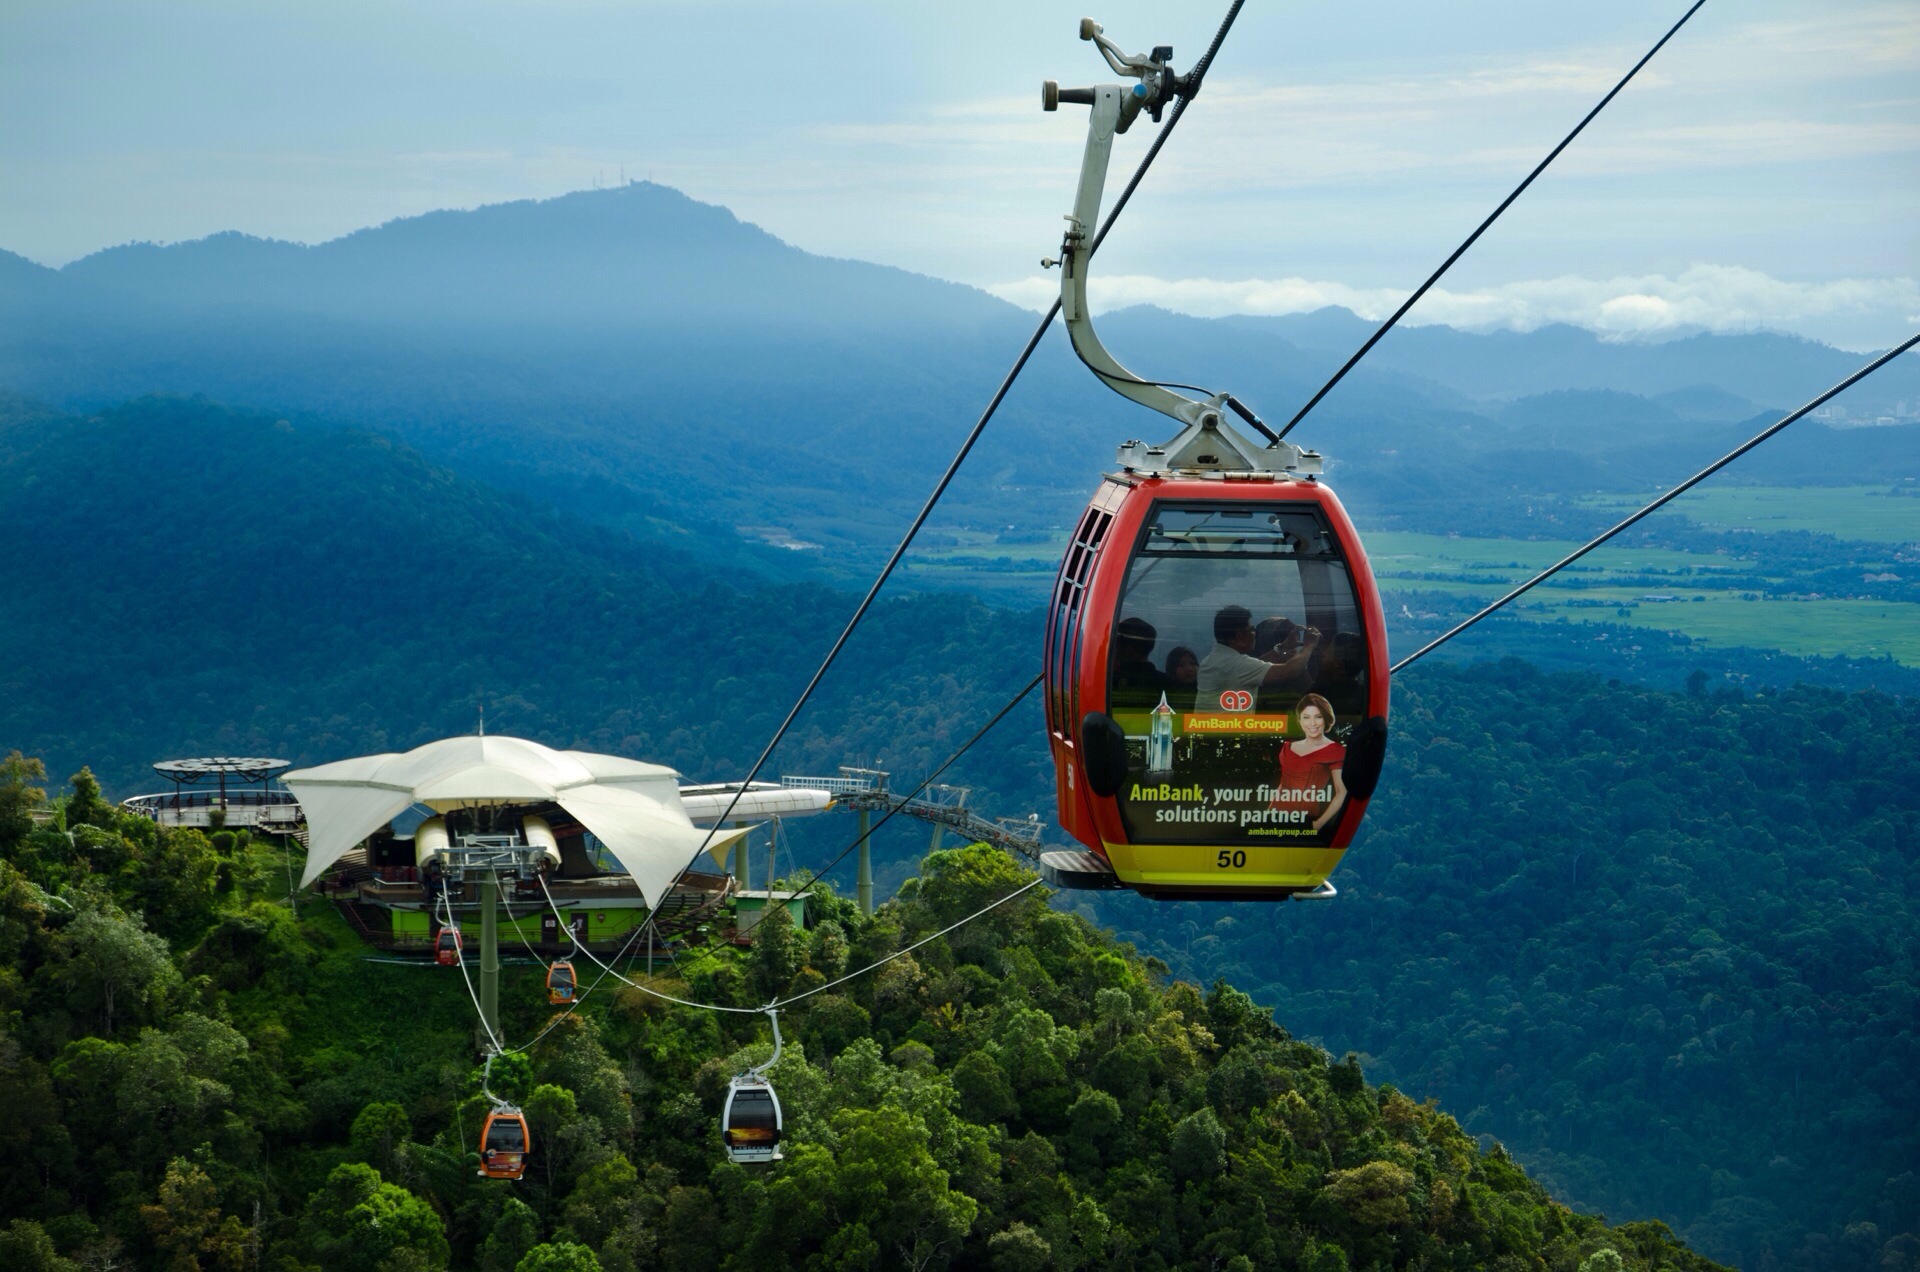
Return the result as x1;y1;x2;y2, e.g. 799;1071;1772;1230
0;755;1715;1272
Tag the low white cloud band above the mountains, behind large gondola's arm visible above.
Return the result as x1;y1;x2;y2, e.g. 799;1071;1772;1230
987;265;1920;348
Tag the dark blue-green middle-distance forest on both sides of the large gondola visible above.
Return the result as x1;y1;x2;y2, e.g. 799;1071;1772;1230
0;400;1920;1266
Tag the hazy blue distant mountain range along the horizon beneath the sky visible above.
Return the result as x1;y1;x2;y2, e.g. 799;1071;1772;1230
0;183;1920;573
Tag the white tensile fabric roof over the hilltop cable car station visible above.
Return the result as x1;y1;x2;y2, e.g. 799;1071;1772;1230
280;738;747;907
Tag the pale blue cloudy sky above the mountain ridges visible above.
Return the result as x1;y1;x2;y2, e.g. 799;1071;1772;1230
0;0;1920;348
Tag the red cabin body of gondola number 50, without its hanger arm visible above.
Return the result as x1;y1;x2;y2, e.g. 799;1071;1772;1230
1044;473;1388;899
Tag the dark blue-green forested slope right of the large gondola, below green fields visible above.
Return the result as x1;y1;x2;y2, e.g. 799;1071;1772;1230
1089;661;1920;1270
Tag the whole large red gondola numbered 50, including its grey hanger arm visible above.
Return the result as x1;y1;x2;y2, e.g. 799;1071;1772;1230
1041;19;1388;899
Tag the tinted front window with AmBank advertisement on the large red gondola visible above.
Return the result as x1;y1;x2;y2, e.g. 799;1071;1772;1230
1108;503;1367;845
